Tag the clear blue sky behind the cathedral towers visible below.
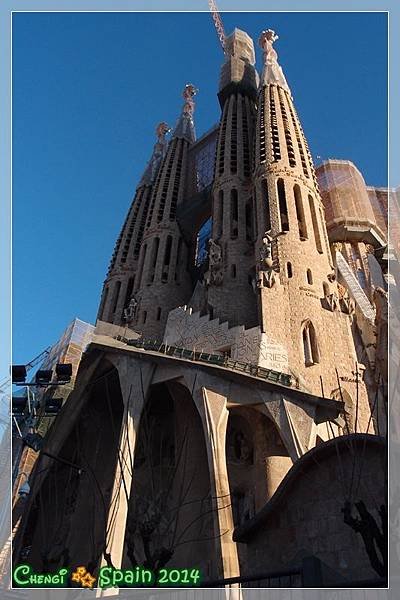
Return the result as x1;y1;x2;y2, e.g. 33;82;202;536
13;13;387;363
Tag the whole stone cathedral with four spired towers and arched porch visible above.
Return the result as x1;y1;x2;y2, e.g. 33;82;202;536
14;29;389;587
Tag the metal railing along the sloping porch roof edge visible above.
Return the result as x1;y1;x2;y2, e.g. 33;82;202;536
117;336;292;387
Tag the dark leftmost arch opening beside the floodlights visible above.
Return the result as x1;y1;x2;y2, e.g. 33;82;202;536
16;359;124;573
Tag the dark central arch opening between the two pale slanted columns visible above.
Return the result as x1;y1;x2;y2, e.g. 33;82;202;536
123;380;216;571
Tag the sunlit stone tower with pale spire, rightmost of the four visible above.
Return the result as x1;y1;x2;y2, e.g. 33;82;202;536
254;30;365;408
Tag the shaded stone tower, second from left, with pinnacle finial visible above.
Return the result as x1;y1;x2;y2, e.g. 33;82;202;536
130;84;196;339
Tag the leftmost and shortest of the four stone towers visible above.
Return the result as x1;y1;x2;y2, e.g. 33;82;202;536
97;123;169;325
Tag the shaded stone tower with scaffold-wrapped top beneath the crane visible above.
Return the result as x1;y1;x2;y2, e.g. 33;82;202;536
207;29;258;326
